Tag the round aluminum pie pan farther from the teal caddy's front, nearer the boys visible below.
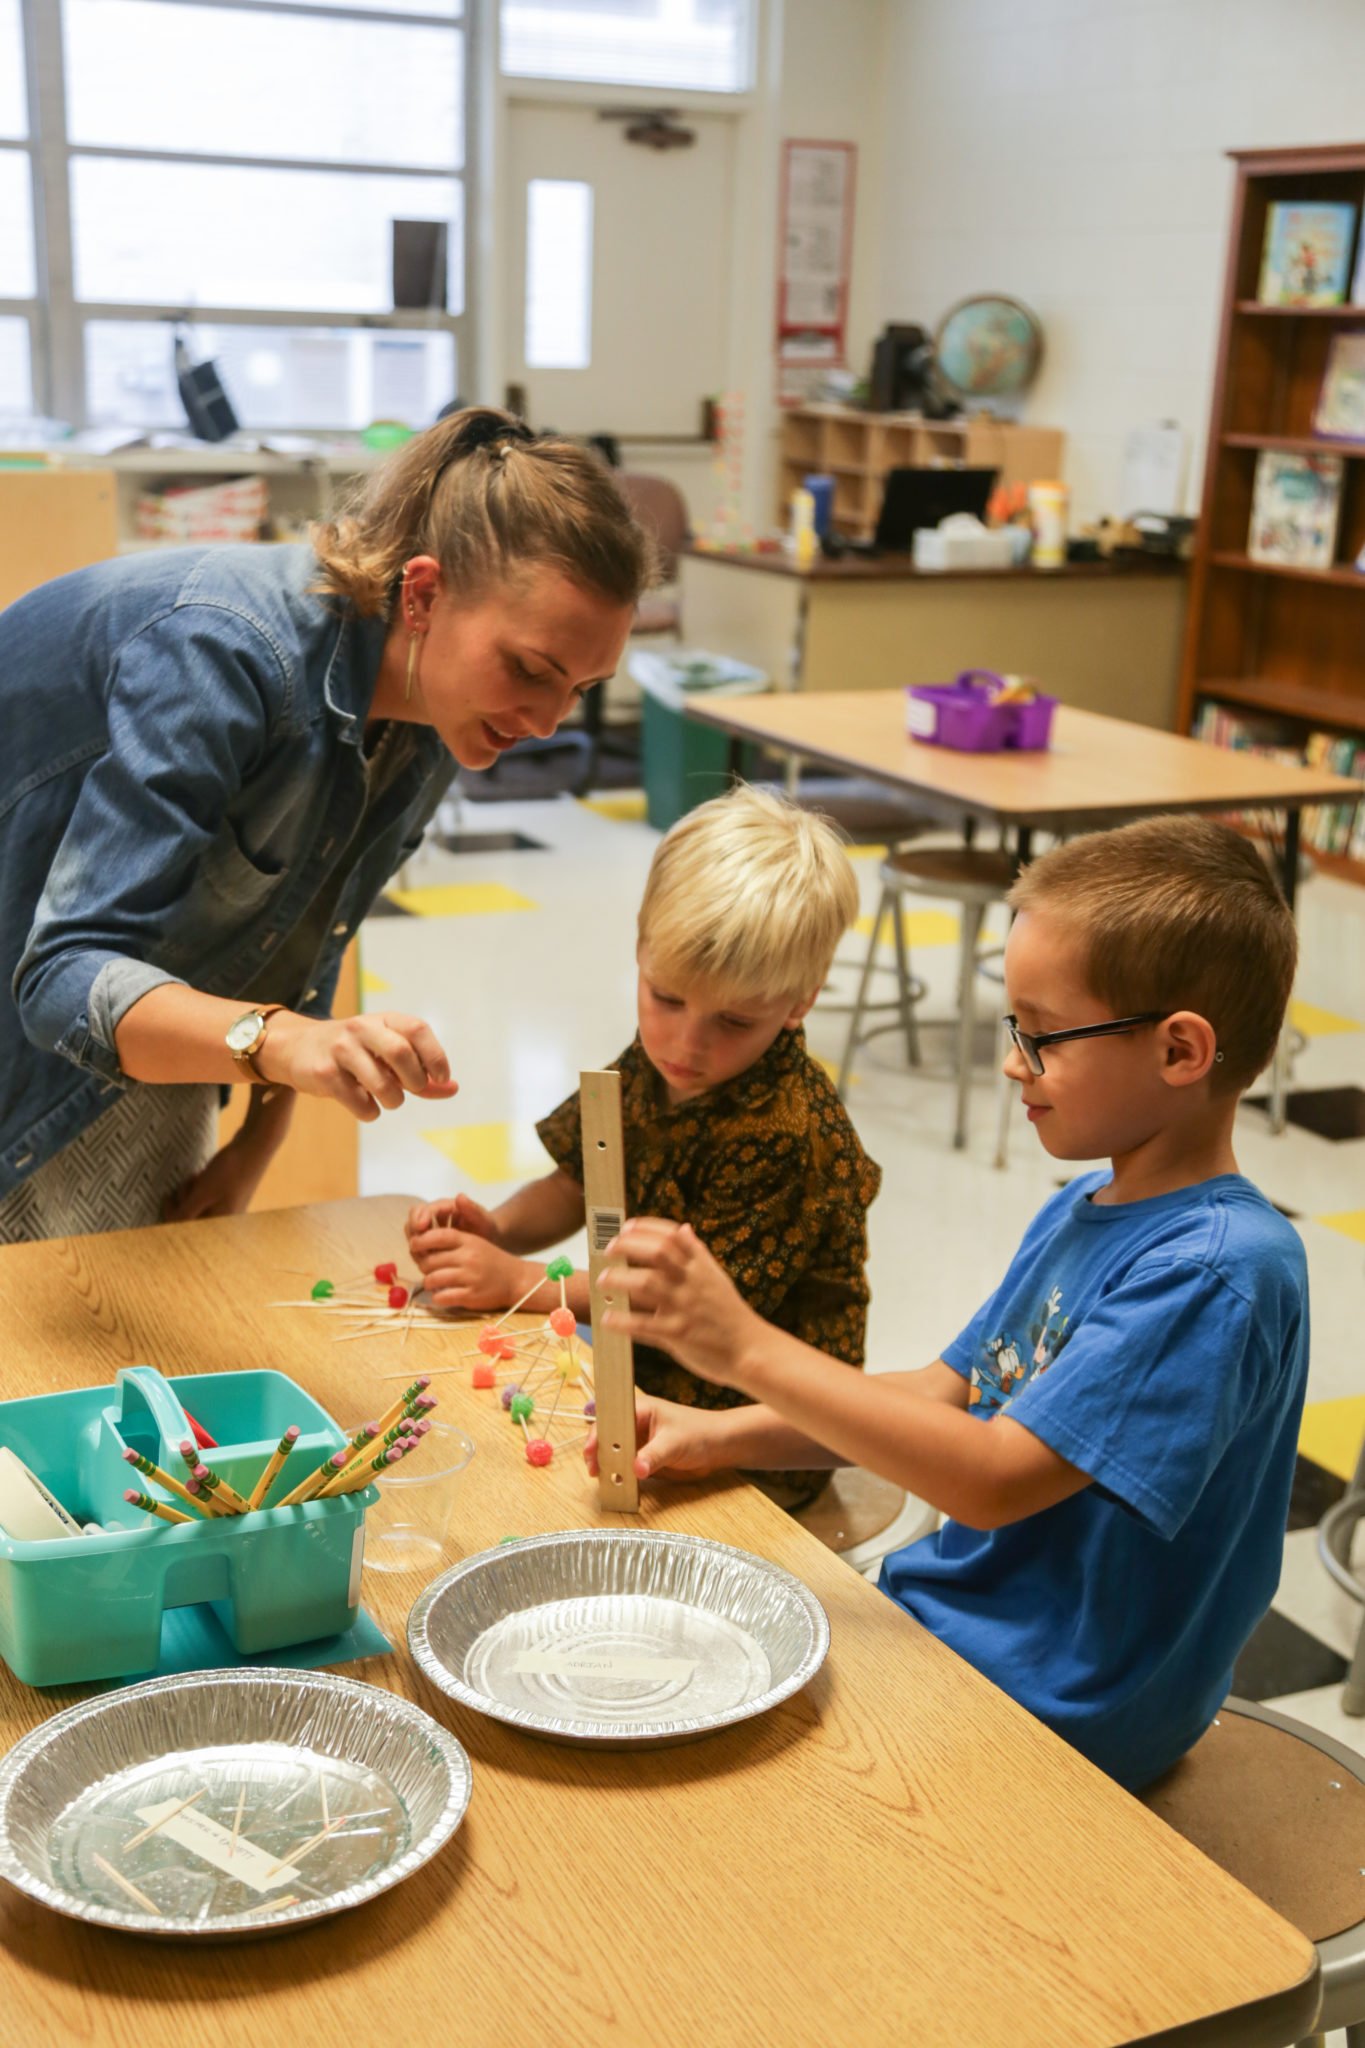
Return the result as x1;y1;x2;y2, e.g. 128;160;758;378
407;1530;829;1749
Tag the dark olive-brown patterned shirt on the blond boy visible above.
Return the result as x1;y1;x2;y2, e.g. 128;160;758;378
536;1026;882;1493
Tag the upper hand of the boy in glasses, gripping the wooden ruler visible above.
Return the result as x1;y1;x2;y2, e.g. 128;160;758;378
602;1217;765;1413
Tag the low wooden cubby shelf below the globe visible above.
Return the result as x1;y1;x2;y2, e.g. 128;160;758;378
778;406;1066;541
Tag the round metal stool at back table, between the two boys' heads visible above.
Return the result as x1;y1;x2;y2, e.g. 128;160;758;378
837;846;1015;1151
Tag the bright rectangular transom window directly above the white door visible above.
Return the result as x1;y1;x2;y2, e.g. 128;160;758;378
501;0;757;92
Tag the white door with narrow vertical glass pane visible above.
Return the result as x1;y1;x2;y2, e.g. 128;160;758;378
503;100;735;438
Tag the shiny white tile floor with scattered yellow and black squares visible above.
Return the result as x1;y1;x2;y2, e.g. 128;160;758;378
360;799;1365;1810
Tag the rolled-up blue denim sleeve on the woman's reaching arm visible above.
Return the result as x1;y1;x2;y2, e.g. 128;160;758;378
14;604;291;1077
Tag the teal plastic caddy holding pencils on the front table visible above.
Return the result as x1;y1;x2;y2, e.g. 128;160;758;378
0;1366;377;1686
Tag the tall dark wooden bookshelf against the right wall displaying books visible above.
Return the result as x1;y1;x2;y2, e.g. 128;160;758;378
1177;143;1365;883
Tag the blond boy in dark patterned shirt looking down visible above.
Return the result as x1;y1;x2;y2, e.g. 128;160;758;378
407;788;882;1505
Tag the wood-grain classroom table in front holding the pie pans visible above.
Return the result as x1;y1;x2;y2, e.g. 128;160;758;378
0;1198;1318;2048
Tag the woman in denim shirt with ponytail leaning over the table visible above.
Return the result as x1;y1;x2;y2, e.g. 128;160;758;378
0;397;651;1243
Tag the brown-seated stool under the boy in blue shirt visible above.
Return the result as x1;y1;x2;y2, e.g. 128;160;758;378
1142;1700;1365;2048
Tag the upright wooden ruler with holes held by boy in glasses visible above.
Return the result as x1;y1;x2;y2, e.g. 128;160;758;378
579;1067;641;1513
